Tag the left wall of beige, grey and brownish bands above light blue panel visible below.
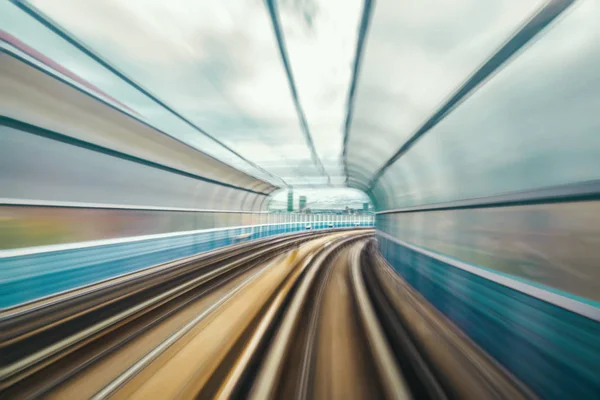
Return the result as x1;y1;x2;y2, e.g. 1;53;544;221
0;48;276;249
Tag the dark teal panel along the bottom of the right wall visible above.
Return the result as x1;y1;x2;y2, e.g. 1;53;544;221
379;236;600;399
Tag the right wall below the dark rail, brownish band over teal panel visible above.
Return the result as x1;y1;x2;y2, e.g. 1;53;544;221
376;190;600;398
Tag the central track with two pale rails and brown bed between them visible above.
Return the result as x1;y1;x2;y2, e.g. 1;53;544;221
250;240;410;399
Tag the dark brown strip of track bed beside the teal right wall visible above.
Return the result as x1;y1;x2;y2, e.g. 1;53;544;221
359;241;536;400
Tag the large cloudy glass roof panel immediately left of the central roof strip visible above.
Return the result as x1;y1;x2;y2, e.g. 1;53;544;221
27;0;332;184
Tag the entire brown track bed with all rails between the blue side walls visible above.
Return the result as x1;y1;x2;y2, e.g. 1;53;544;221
0;230;533;399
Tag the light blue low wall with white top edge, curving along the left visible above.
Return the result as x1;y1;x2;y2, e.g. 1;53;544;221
0;214;373;309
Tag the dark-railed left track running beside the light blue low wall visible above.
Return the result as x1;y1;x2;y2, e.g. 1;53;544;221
0;233;346;398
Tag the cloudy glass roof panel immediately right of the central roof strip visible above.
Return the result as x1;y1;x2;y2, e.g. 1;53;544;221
348;0;542;184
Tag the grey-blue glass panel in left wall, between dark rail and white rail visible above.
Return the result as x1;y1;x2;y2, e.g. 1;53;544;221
0;126;246;211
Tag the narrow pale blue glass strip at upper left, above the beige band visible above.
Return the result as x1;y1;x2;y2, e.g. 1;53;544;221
0;2;280;184
